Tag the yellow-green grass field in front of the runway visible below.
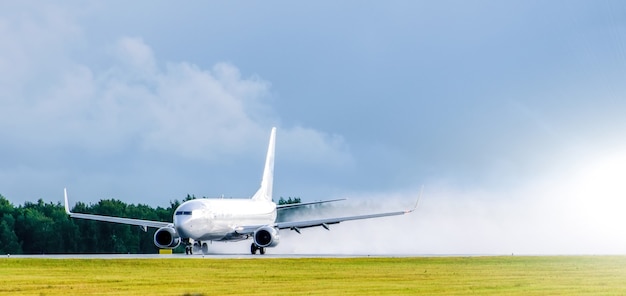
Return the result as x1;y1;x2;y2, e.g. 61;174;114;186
0;256;626;295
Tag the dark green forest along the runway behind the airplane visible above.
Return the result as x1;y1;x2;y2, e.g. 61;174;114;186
0;194;300;254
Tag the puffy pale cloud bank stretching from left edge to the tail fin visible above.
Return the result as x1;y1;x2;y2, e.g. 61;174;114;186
0;8;349;161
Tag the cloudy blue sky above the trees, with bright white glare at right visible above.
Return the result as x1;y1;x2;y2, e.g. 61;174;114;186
0;0;626;254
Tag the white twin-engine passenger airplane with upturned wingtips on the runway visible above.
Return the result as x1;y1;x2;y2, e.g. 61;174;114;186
63;127;423;255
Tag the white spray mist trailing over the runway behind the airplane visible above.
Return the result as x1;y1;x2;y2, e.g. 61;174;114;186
205;147;626;255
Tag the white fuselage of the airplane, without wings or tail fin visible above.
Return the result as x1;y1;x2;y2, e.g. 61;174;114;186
173;199;276;241
